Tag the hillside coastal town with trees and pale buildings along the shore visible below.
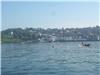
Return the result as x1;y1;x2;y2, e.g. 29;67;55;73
1;26;100;42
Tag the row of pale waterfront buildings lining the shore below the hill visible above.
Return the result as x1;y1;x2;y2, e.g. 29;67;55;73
39;34;100;42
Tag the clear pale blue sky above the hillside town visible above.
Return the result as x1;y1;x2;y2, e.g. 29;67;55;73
1;0;99;30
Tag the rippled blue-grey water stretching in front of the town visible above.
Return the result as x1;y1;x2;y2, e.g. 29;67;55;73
2;42;100;75
